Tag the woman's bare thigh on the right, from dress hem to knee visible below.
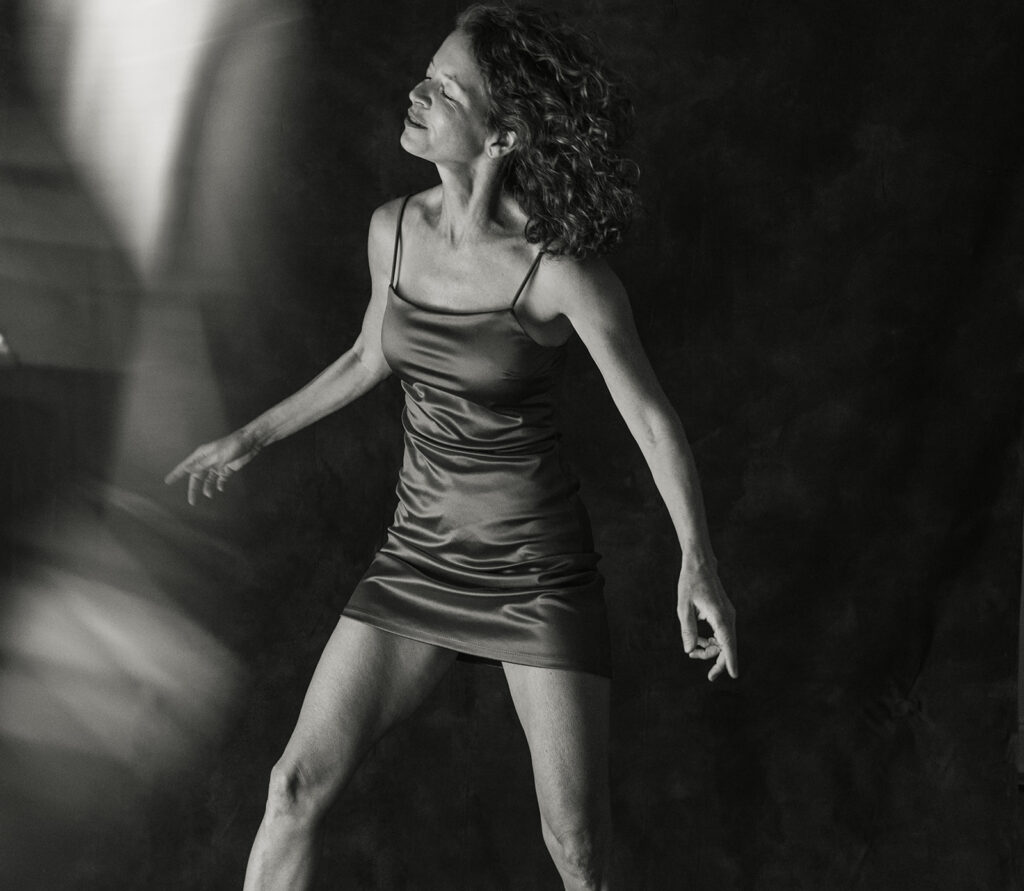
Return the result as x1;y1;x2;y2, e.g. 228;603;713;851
504;663;609;833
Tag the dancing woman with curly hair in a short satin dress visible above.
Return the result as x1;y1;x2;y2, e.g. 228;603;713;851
167;6;737;889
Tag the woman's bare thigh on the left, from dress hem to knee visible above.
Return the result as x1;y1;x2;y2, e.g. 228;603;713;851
281;616;456;790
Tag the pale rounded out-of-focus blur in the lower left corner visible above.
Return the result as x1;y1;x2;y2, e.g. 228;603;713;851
0;499;242;782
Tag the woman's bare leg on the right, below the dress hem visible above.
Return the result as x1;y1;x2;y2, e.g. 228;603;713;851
504;663;625;891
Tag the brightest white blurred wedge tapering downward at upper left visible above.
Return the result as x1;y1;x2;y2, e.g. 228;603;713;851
27;0;224;269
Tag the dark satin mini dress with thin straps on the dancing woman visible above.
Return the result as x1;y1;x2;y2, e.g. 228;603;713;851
342;197;611;677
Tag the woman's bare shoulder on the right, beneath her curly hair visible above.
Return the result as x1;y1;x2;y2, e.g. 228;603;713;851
538;255;630;329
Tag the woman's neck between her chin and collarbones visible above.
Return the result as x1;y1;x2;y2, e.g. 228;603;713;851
437;158;508;248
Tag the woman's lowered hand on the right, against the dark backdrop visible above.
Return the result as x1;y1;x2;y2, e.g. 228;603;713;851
676;564;739;681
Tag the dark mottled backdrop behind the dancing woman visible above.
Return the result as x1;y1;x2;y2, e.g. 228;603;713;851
0;0;1024;891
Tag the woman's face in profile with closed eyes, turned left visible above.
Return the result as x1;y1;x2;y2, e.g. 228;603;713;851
401;31;494;164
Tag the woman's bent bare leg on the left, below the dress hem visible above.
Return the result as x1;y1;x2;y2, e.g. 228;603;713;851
245;616;456;891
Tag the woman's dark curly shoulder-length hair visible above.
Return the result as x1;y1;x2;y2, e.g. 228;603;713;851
456;3;639;258
